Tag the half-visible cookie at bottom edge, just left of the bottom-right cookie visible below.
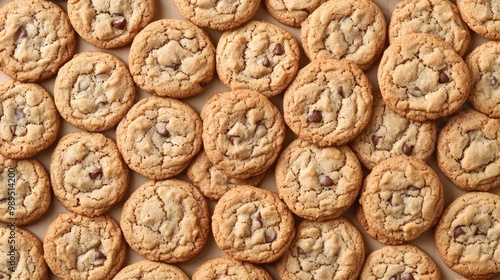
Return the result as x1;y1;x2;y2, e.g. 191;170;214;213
360;244;442;280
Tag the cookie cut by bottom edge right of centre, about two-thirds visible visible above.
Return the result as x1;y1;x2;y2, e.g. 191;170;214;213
276;218;365;280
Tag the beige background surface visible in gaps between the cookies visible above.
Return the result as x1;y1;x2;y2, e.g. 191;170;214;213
0;0;500;279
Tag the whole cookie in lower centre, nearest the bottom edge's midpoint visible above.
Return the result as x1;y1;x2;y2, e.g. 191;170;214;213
212;185;295;263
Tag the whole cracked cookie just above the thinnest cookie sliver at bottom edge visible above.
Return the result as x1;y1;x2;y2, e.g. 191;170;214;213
120;179;210;263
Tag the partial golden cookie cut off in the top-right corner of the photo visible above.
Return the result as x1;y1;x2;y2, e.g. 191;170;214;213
457;0;500;40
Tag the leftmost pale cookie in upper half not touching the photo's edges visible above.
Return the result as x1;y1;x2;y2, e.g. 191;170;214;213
54;52;135;131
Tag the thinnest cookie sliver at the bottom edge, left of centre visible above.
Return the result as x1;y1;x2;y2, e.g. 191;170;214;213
113;260;189;280
